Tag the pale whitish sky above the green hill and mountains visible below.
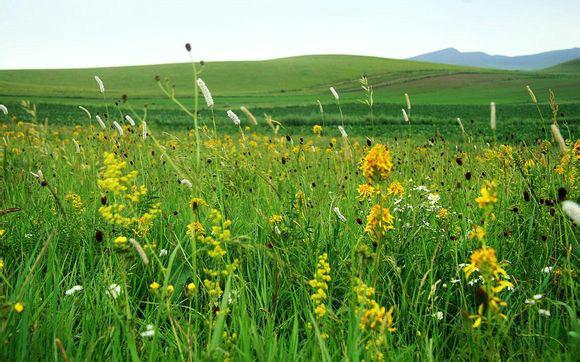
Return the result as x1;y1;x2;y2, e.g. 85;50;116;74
0;0;580;69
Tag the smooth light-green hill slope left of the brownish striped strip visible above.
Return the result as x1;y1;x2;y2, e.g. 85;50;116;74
0;55;468;98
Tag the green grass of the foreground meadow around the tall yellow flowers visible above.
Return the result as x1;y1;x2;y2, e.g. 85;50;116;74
0;116;580;361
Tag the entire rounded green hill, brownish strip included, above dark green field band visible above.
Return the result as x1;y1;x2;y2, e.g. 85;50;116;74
0;55;580;106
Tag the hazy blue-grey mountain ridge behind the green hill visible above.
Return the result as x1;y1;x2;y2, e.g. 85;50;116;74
408;48;580;70
